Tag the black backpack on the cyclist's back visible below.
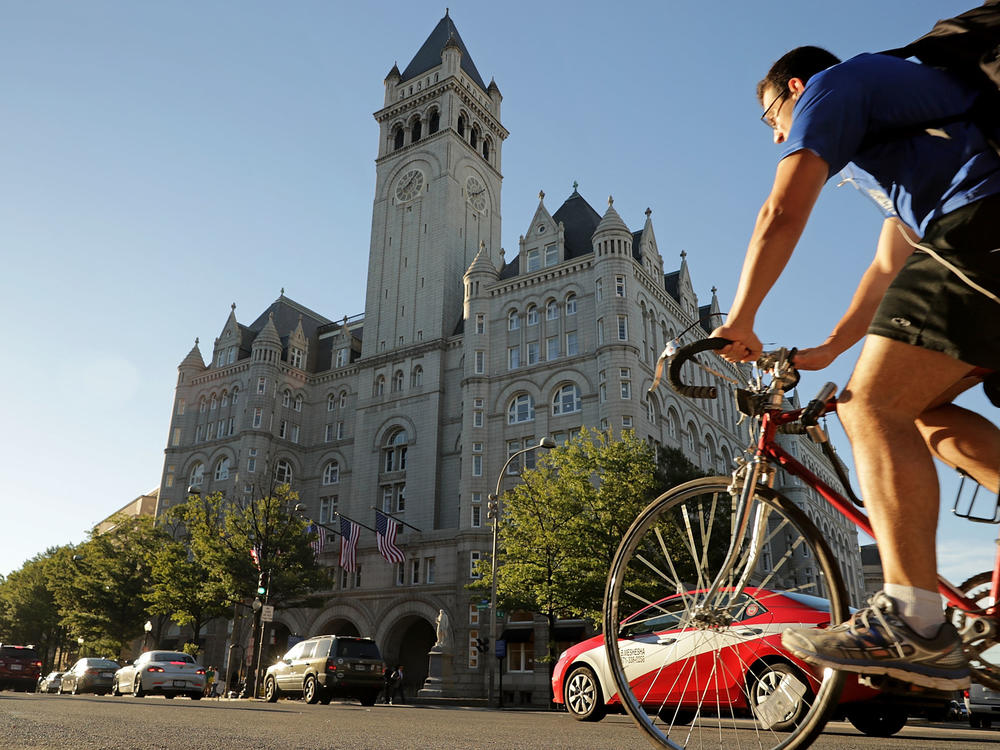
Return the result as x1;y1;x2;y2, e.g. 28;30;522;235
865;0;1000;154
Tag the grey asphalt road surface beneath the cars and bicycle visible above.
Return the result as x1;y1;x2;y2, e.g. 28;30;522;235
0;692;1000;750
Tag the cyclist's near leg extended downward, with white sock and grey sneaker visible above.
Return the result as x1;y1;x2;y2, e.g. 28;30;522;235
782;335;971;690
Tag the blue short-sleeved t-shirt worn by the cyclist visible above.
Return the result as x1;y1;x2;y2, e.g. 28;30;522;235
781;54;1000;235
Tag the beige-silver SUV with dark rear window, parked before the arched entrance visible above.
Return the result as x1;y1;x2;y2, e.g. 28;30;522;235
264;635;382;706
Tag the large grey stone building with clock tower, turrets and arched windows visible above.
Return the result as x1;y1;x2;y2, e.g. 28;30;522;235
152;10;860;704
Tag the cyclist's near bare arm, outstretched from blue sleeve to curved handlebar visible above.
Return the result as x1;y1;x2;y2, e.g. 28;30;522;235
712;150;829;361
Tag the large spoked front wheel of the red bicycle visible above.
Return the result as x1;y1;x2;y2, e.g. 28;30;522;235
604;477;848;750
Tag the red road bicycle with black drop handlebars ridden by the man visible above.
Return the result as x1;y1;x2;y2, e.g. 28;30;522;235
603;339;1000;750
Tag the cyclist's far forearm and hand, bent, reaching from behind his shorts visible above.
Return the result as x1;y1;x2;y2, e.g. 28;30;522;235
795;217;919;370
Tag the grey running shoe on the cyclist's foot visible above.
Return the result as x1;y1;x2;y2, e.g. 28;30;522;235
781;591;969;690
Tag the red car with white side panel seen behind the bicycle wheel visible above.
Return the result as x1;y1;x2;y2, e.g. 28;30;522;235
552;587;947;736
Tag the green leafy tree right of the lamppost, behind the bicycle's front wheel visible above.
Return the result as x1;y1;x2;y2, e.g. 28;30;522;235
475;428;701;663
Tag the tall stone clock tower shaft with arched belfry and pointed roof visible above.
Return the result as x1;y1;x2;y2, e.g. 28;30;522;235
362;13;507;358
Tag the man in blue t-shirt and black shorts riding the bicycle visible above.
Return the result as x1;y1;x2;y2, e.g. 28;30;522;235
712;47;1000;690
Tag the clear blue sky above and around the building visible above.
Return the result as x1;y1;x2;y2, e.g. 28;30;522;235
0;0;997;580
